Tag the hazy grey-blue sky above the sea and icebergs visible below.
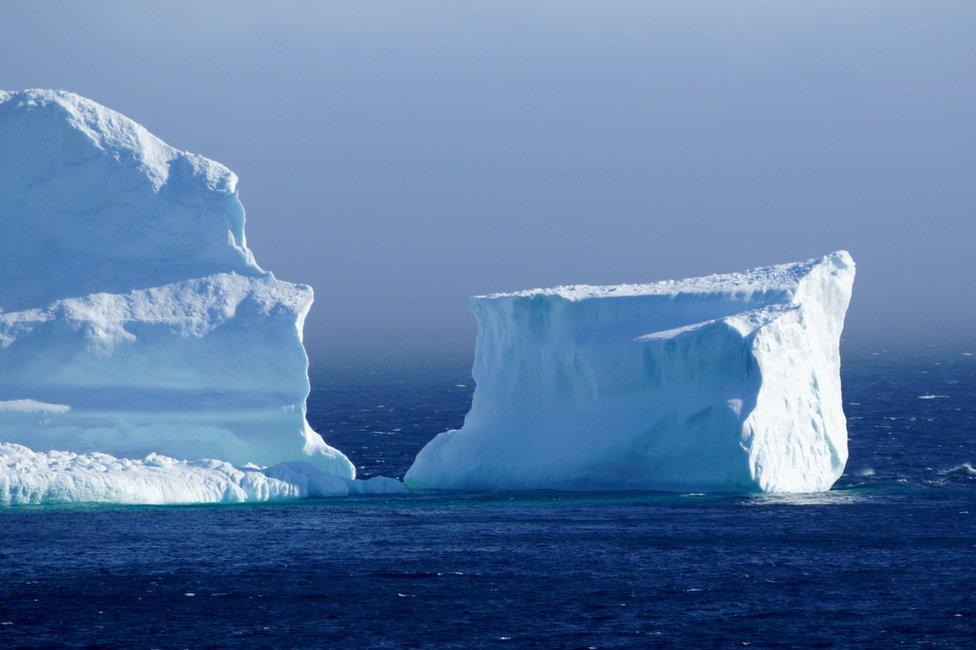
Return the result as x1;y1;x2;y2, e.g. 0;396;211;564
0;0;976;351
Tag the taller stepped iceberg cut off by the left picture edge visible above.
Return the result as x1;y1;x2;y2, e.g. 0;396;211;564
0;90;402;503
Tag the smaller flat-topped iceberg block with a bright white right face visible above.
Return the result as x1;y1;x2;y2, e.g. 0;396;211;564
404;251;854;492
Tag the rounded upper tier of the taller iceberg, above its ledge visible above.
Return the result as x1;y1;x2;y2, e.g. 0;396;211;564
0;90;264;309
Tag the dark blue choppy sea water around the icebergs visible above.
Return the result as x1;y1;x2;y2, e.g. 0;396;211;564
0;349;976;648
